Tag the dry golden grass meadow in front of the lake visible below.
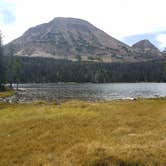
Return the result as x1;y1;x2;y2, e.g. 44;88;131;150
0;99;166;166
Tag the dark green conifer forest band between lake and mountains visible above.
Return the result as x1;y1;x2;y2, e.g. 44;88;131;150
5;57;166;83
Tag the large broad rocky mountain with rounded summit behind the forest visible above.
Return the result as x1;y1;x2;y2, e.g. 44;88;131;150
4;17;163;62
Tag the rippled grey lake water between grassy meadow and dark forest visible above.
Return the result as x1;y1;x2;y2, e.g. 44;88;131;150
10;83;166;102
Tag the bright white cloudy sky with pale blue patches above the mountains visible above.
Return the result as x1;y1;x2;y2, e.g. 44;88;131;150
0;0;166;50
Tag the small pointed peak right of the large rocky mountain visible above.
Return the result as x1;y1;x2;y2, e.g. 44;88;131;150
132;40;162;59
